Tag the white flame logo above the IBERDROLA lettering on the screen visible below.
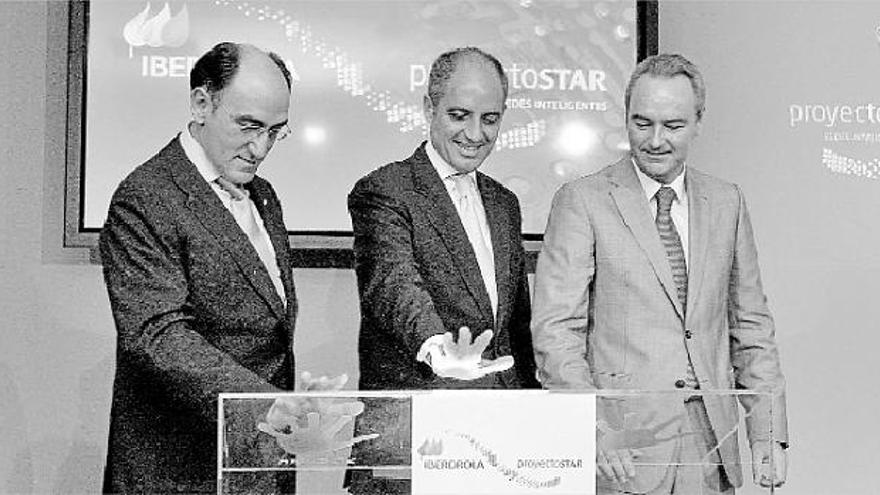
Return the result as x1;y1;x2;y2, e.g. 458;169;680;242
122;2;189;58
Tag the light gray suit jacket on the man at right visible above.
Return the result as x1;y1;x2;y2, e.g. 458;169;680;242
532;157;788;491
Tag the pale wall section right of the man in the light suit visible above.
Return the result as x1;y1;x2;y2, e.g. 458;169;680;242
659;1;880;495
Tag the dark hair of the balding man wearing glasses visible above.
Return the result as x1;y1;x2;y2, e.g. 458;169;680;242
189;41;291;98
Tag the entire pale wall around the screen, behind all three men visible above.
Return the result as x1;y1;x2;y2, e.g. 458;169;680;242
0;1;880;495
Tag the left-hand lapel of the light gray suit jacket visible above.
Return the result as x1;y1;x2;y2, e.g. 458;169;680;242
610;157;684;321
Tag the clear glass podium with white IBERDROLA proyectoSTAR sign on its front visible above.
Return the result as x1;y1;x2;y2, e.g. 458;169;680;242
217;390;775;495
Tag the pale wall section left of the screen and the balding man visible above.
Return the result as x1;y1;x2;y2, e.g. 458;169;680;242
0;2;113;493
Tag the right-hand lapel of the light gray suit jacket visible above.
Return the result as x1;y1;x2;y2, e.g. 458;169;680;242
685;169;711;326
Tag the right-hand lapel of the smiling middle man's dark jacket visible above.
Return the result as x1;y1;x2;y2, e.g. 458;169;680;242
477;173;511;328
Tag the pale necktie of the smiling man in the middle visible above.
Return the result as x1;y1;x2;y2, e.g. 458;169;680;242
450;174;498;314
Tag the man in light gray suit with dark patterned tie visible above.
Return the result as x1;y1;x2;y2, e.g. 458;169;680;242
532;54;788;494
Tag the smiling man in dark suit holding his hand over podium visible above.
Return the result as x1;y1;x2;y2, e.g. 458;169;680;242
348;48;538;490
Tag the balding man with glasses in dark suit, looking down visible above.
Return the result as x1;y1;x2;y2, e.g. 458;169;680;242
100;43;297;493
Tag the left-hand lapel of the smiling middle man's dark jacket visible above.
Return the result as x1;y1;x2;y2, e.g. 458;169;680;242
410;147;497;321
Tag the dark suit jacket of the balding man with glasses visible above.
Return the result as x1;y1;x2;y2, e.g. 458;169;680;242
100;138;297;493
